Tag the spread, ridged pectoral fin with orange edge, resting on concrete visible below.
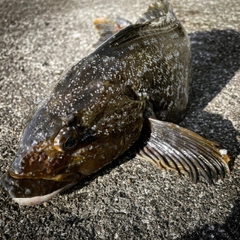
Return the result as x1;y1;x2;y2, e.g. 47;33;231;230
137;119;230;183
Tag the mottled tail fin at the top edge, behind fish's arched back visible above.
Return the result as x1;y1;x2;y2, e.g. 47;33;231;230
137;0;176;23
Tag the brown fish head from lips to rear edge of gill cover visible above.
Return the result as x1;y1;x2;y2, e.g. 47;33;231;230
1;58;145;205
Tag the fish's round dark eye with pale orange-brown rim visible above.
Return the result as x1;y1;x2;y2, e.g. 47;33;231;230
54;127;78;152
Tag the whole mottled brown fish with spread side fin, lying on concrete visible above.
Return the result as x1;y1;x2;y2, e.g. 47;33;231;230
1;0;229;205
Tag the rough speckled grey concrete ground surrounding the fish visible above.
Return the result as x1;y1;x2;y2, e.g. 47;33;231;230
0;0;240;240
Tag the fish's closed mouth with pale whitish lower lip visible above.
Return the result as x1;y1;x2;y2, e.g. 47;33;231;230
0;172;81;205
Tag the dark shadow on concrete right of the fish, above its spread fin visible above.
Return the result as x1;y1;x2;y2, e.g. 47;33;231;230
183;30;240;163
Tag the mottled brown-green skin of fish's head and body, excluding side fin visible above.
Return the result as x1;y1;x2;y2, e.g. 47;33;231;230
0;1;191;200
